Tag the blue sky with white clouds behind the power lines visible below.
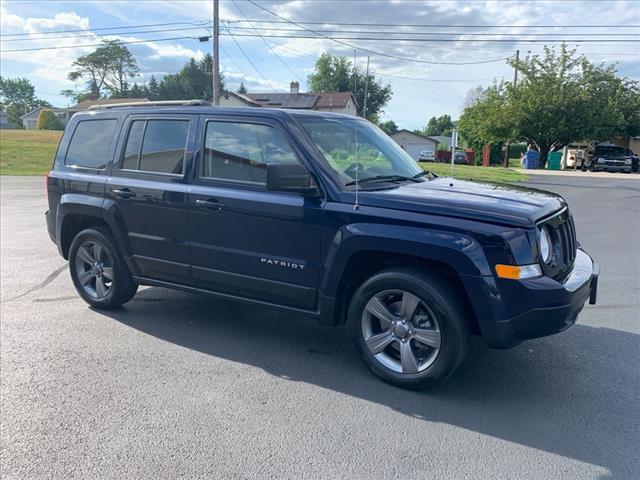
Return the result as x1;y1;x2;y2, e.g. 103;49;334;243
0;0;640;128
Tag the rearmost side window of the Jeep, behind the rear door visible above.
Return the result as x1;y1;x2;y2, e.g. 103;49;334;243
64;119;118;169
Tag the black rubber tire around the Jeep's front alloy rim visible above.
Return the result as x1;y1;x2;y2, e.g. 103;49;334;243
347;268;469;389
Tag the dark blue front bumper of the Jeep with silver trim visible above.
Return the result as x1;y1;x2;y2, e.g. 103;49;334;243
478;249;600;348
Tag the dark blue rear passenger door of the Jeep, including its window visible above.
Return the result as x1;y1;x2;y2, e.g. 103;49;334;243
105;114;198;285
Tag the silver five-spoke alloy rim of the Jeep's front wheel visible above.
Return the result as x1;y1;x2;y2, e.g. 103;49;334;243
362;290;441;374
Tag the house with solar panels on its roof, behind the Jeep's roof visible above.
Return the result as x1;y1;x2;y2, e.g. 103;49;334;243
220;82;358;116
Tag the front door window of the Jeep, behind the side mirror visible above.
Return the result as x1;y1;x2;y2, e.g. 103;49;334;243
201;121;299;184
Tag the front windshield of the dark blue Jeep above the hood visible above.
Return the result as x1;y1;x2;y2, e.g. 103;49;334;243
299;115;422;186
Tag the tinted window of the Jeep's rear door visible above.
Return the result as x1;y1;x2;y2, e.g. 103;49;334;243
122;119;189;175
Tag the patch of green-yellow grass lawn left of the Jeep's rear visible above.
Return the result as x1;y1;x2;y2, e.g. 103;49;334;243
0;130;62;175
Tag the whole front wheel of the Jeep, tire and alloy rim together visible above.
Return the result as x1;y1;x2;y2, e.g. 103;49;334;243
348;268;468;388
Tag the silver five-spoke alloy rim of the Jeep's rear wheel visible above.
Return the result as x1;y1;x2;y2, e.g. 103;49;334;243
75;240;113;300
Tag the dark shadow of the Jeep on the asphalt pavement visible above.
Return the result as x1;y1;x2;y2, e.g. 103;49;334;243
101;288;640;478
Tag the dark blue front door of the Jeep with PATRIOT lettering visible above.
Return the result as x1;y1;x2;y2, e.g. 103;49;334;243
189;116;324;309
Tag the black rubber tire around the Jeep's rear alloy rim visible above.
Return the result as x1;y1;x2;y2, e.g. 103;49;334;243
69;227;138;310
